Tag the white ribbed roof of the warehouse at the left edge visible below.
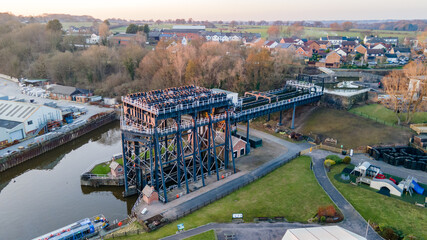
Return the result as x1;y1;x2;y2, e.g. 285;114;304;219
0;100;40;122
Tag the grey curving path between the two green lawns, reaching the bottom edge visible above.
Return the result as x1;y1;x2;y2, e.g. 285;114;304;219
308;150;382;240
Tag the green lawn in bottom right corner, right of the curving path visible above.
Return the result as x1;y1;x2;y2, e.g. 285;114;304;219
328;164;427;239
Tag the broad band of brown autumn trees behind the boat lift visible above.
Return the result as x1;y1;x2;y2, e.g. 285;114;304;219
0;15;304;97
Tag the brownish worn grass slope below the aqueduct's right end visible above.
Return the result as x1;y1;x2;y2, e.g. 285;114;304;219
301;108;411;148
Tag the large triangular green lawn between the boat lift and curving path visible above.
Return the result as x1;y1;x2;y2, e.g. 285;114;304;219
114;156;333;240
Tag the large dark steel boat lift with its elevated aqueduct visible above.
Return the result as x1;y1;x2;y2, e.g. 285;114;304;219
120;81;323;203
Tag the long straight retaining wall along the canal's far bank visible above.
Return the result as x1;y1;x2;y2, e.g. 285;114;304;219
0;112;117;172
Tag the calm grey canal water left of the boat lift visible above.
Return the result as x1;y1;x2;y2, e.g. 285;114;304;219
0;122;136;239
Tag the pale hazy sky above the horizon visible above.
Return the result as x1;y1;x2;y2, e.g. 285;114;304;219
0;0;427;21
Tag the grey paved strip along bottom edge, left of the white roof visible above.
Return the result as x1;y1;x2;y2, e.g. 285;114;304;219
162;223;319;240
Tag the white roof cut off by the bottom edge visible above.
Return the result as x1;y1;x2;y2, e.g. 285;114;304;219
282;226;366;240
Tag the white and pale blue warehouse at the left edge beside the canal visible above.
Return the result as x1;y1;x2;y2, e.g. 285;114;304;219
0;100;62;145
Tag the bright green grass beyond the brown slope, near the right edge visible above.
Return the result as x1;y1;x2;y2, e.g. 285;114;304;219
350;104;427;124
